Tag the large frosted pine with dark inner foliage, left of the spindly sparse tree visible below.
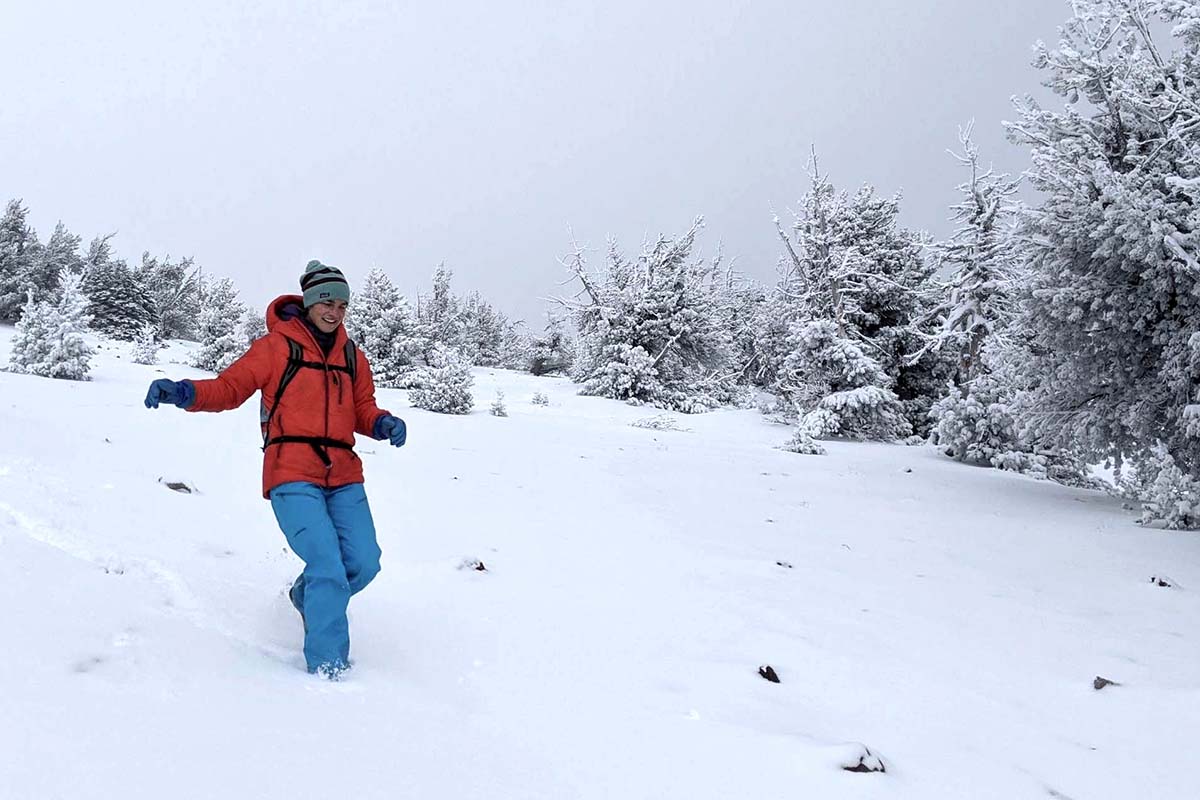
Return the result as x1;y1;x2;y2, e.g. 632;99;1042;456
755;157;946;438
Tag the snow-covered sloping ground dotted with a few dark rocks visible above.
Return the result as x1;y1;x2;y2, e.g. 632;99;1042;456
0;327;1200;800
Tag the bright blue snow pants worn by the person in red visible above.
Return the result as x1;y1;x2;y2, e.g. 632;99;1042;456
270;482;380;672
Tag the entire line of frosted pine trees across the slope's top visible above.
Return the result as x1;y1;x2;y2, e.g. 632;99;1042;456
9;0;1200;528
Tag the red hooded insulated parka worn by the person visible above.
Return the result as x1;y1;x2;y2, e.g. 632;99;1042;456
187;295;388;498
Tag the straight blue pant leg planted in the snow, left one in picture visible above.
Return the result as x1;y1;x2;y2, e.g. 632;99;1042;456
271;483;350;672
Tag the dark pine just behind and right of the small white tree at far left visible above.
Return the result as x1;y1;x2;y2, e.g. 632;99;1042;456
83;235;154;341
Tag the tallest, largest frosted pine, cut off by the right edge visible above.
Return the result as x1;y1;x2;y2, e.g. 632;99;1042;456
1008;0;1200;475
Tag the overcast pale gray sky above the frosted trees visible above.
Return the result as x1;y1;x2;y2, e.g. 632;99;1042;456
0;0;1069;320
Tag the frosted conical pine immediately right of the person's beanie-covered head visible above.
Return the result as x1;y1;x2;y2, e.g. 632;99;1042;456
346;267;426;387
